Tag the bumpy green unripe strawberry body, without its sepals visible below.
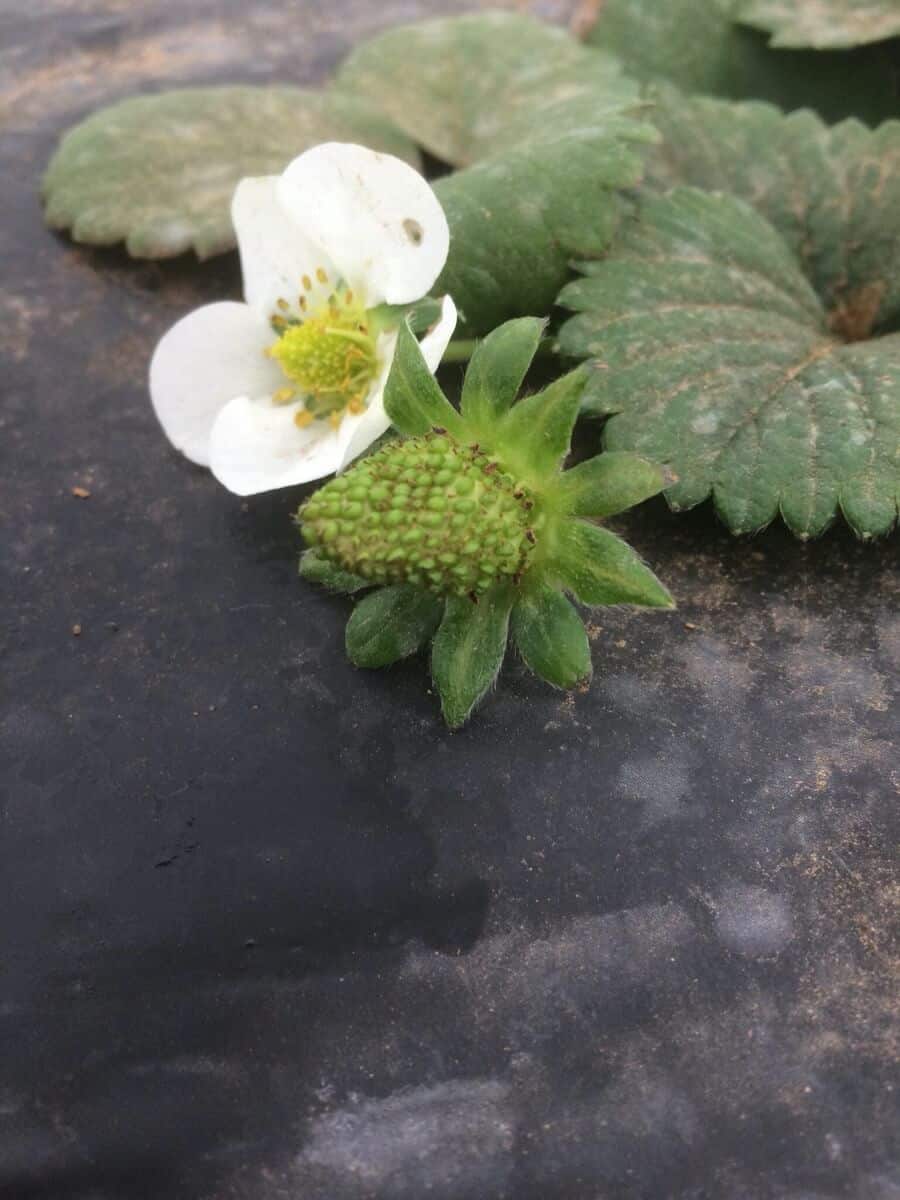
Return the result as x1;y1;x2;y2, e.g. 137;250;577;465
299;432;536;596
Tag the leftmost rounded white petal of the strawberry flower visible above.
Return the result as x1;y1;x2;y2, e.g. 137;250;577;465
150;300;284;467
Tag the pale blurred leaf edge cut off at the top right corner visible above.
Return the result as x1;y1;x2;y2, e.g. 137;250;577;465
737;0;900;50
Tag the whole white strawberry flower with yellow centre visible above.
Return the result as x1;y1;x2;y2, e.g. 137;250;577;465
150;142;456;496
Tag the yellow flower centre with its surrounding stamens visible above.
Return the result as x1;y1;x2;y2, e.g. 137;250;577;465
266;272;378;428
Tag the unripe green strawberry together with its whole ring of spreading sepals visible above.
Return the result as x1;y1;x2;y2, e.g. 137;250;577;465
298;318;672;726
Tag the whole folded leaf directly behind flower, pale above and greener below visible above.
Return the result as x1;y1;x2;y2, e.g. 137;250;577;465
337;12;656;334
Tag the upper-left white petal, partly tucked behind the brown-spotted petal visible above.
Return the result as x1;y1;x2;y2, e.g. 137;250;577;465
232;175;337;319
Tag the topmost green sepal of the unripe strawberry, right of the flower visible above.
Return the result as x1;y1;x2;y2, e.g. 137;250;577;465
460;317;547;428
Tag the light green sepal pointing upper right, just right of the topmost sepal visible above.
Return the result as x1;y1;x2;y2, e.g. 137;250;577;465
497;365;588;475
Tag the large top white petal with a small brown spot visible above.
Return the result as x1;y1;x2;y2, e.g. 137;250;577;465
280;142;450;307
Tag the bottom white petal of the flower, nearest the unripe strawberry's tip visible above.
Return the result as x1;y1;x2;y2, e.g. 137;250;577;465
210;396;341;496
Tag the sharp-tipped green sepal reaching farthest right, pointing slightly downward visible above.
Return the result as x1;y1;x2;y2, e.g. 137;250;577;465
553;521;674;608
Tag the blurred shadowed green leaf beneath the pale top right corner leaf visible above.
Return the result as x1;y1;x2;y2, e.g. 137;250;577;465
587;0;900;125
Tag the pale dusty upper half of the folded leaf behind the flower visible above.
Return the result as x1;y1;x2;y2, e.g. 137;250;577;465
335;12;640;167
